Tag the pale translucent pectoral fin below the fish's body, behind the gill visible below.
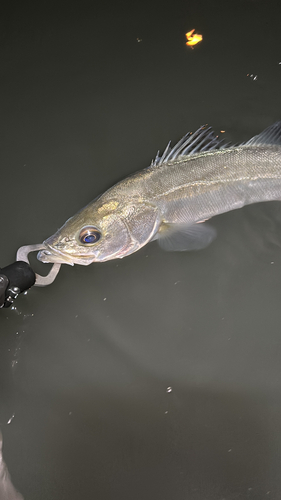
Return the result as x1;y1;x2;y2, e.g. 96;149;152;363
156;223;217;252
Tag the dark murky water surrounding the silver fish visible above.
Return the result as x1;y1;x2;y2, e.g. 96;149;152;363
0;0;281;500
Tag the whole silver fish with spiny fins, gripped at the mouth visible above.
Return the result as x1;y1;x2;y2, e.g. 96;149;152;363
37;121;281;265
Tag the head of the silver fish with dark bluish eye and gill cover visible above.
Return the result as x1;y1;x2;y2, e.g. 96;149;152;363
37;197;160;266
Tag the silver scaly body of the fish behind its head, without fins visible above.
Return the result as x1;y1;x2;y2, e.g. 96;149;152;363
116;146;281;224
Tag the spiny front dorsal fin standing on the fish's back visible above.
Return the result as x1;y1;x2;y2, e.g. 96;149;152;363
151;125;225;167
